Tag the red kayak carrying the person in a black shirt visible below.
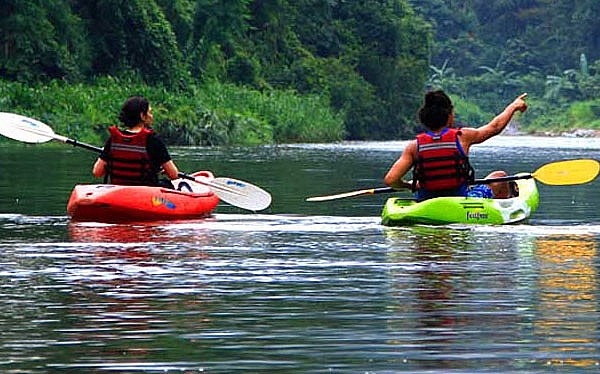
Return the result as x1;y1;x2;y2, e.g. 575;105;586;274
67;171;219;223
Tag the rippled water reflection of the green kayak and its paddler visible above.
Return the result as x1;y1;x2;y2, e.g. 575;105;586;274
386;227;473;368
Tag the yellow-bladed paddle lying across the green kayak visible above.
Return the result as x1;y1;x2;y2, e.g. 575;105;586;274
306;159;600;201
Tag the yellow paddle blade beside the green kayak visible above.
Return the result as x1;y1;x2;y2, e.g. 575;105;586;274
532;159;600;186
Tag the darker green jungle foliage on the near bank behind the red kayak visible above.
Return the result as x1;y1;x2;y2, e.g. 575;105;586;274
0;0;431;144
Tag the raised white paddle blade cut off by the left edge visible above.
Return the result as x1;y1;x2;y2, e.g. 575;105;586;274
0;112;56;143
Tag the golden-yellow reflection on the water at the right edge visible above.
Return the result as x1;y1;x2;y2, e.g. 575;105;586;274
534;235;598;367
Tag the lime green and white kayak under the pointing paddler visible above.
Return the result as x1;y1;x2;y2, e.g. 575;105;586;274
381;174;539;226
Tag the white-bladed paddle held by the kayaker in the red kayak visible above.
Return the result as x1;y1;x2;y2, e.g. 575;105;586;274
0;112;271;211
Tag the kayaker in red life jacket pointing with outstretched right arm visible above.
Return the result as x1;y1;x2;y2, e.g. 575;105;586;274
384;90;527;200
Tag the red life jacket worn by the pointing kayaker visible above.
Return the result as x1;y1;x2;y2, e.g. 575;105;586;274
413;128;475;193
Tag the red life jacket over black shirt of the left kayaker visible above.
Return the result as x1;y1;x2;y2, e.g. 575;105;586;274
108;126;155;185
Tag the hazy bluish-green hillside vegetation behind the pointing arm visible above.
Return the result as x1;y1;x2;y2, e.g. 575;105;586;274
410;0;600;131
